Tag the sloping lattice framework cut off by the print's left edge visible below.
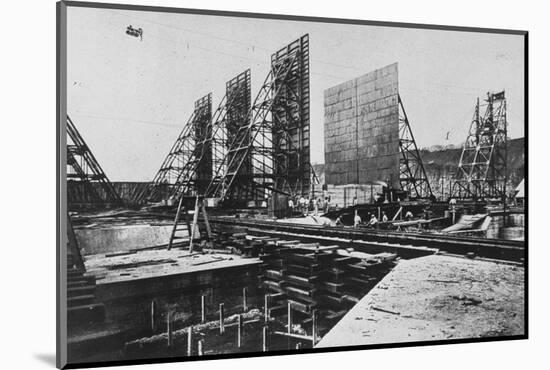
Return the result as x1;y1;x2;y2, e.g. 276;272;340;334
67;116;122;204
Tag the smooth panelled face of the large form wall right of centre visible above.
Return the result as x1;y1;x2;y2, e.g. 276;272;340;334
325;63;399;187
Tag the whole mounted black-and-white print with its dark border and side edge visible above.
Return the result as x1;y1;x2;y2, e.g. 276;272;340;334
57;2;532;367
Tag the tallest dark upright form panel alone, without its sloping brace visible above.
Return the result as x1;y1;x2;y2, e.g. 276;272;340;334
270;35;311;196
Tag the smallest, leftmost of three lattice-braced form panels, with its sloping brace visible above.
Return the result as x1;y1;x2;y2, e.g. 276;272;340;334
133;93;212;204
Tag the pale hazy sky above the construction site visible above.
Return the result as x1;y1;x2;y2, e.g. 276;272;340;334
67;7;524;181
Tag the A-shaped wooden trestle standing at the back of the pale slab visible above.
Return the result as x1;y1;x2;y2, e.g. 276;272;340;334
168;195;212;253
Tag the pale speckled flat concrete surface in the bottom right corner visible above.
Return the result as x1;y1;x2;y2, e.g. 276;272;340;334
316;255;525;347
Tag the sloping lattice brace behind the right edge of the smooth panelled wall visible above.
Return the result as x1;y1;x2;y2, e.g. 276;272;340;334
398;96;433;199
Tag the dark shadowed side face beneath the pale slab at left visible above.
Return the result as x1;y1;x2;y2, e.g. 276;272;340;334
96;265;263;332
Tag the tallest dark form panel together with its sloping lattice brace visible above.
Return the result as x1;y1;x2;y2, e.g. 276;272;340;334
205;35;310;201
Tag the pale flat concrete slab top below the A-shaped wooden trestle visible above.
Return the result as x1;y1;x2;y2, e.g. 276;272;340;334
84;249;260;285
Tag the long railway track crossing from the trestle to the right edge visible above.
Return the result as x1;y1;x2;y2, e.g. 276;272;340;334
209;216;526;262
